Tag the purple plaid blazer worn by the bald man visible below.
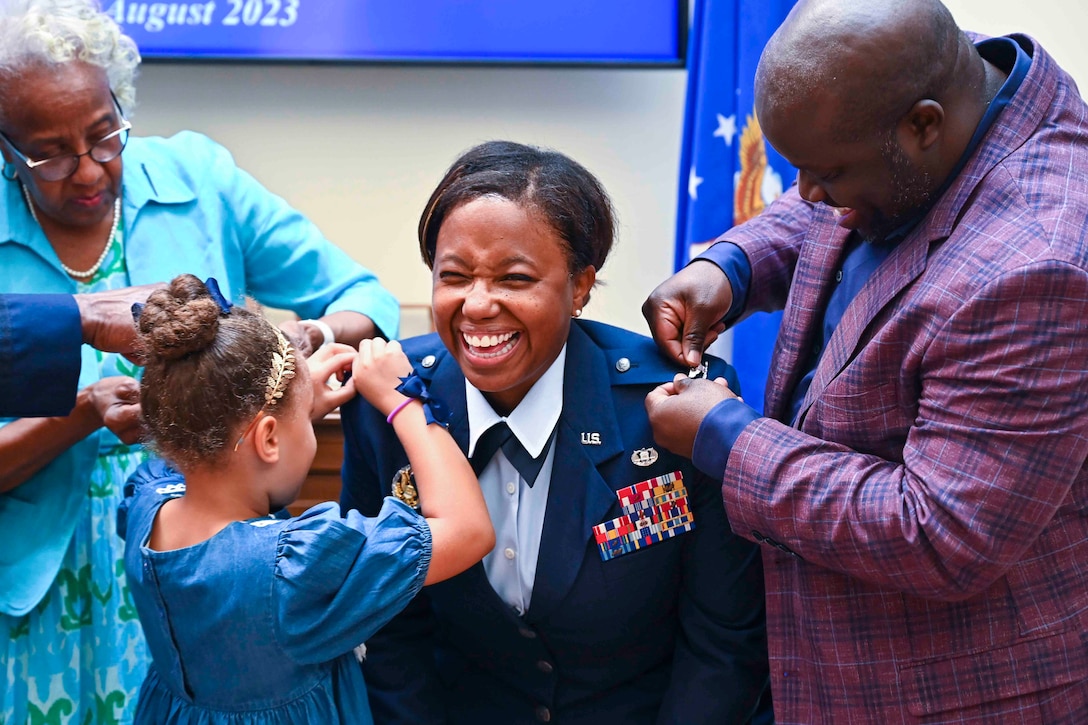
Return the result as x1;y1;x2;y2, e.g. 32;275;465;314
722;36;1088;725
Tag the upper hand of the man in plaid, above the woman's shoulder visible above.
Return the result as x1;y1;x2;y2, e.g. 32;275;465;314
642;261;733;368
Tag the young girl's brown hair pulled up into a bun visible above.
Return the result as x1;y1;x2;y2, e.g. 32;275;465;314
136;274;302;469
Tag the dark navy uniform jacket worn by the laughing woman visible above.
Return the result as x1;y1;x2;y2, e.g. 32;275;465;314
342;320;767;725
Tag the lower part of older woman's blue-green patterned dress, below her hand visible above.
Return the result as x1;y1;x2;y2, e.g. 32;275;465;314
0;445;150;725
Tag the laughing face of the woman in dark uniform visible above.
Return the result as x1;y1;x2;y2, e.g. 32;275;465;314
431;196;596;415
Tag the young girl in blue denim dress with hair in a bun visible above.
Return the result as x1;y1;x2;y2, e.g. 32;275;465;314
119;275;494;725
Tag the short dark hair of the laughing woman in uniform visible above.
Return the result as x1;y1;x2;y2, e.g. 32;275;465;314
419;140;616;272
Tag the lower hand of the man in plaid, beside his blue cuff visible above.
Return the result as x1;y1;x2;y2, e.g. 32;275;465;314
646;373;739;458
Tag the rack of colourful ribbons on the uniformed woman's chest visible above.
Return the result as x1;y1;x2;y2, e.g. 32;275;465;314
593;470;695;562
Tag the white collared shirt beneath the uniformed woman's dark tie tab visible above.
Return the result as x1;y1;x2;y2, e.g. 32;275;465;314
465;345;567;616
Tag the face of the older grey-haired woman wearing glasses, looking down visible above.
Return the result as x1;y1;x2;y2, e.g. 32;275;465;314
0;62;122;228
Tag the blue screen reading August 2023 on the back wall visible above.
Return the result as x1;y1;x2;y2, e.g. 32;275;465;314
102;0;688;65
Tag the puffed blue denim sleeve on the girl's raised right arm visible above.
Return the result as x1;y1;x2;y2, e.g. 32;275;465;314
272;497;431;663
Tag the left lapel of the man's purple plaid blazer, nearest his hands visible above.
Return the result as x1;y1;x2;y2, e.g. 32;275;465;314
766;208;850;423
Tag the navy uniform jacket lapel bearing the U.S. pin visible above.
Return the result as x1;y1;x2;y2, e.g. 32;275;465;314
527;324;623;622
